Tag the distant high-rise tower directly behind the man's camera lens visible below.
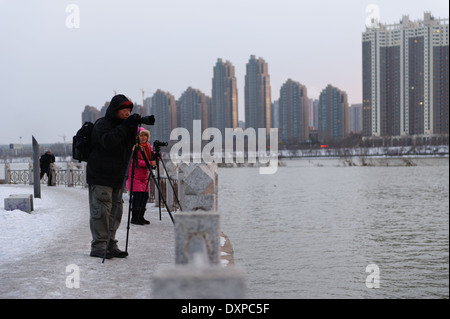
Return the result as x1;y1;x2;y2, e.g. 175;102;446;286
150;90;178;142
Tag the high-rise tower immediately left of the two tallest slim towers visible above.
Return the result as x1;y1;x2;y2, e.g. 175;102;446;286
177;87;211;136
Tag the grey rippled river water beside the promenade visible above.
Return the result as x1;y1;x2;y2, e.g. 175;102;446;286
219;158;449;299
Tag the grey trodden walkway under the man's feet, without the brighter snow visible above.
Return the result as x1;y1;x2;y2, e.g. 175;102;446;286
0;188;233;299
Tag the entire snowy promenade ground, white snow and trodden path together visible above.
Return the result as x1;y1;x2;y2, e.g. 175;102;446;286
0;184;228;299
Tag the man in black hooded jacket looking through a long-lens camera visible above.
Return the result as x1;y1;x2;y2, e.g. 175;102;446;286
87;94;139;259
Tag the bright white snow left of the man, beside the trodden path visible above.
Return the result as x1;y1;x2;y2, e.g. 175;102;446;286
0;185;89;264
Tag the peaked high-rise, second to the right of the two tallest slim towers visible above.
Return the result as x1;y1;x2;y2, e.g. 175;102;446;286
317;84;349;142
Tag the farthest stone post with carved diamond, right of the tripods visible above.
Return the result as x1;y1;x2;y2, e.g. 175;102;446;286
178;163;218;211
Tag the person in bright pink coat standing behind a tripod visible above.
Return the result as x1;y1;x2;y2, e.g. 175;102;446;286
127;127;156;225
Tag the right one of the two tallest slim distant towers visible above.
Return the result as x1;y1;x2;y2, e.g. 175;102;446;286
245;55;272;134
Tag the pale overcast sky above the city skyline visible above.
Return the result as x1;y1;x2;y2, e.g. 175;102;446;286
0;0;449;144
